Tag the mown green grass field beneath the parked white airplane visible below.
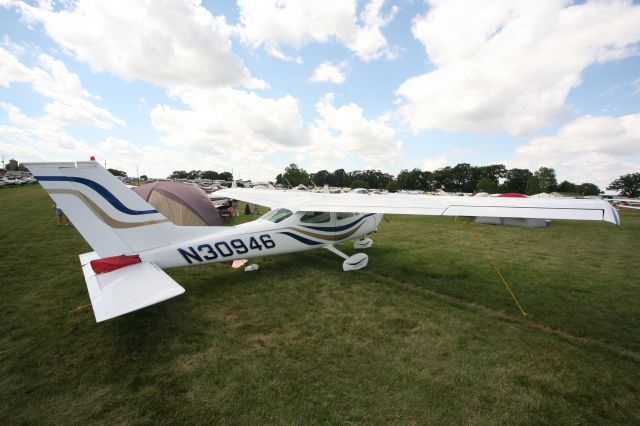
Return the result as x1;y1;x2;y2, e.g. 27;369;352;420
0;186;640;424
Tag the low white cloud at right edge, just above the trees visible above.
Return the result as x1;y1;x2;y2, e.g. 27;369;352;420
508;114;640;189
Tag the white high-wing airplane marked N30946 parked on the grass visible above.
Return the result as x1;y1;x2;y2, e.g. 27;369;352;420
26;161;620;322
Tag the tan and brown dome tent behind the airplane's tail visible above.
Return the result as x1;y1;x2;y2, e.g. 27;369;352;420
132;181;222;226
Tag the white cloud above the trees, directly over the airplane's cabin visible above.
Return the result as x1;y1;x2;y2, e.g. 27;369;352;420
309;93;402;168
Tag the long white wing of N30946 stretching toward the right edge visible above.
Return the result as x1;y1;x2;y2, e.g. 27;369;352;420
219;188;620;225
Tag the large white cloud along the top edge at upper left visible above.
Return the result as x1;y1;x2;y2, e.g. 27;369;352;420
17;0;264;87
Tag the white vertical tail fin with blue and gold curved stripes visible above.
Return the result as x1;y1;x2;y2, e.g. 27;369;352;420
25;161;178;257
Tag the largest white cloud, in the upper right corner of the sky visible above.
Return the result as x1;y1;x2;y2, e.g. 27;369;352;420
397;0;640;136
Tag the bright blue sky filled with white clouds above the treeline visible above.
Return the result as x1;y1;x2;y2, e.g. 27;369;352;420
0;0;640;189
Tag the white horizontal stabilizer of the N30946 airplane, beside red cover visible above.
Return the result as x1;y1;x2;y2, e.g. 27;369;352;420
80;252;184;322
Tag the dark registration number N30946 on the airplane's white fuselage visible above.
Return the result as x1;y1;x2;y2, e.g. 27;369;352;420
178;234;276;264
